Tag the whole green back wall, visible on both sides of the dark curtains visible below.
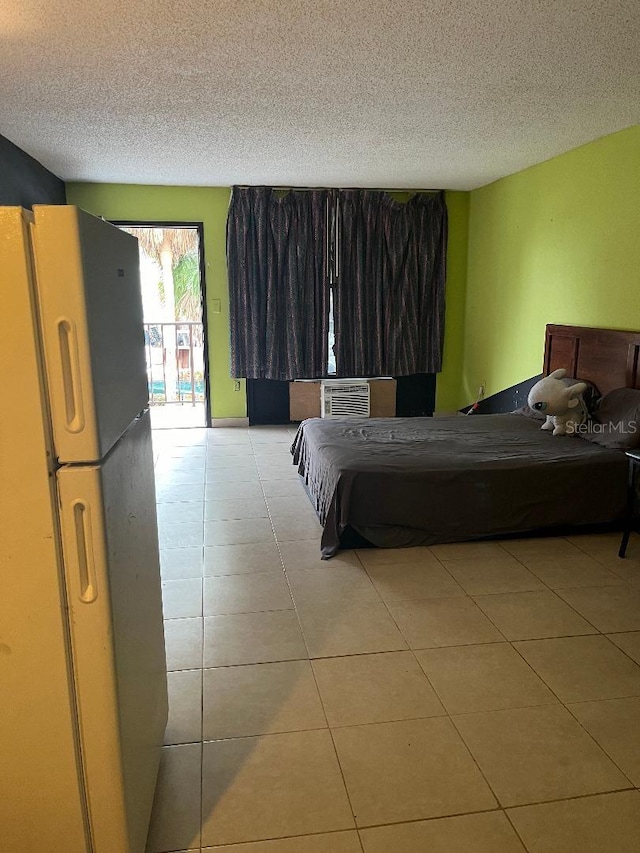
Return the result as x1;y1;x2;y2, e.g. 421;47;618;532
67;183;469;418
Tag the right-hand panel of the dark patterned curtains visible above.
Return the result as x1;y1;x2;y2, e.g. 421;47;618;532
333;190;447;376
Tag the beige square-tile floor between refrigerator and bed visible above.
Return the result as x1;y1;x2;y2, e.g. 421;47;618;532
148;427;640;853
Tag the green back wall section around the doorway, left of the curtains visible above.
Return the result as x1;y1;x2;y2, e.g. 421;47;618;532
67;183;246;418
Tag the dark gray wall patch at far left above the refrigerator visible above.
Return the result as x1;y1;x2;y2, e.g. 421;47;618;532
0;136;67;207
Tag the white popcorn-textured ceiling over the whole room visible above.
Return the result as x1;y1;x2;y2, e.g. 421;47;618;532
0;0;640;189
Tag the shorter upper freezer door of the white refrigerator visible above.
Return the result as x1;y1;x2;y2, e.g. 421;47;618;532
31;205;149;463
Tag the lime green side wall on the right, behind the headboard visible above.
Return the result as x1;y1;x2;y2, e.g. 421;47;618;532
457;126;640;405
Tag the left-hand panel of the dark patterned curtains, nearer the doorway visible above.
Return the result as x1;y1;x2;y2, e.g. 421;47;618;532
227;187;331;379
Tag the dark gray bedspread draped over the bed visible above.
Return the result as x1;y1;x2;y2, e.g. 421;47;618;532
291;414;627;558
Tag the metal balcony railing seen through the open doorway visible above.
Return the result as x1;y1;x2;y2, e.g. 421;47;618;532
144;322;205;406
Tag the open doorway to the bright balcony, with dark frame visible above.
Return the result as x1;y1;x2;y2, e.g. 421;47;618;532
114;222;211;429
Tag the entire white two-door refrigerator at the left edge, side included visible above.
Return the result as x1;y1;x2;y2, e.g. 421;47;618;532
0;205;167;853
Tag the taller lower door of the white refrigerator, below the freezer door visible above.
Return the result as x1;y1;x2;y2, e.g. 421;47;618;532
57;412;167;853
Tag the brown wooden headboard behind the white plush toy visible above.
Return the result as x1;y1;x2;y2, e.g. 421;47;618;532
543;325;640;394
